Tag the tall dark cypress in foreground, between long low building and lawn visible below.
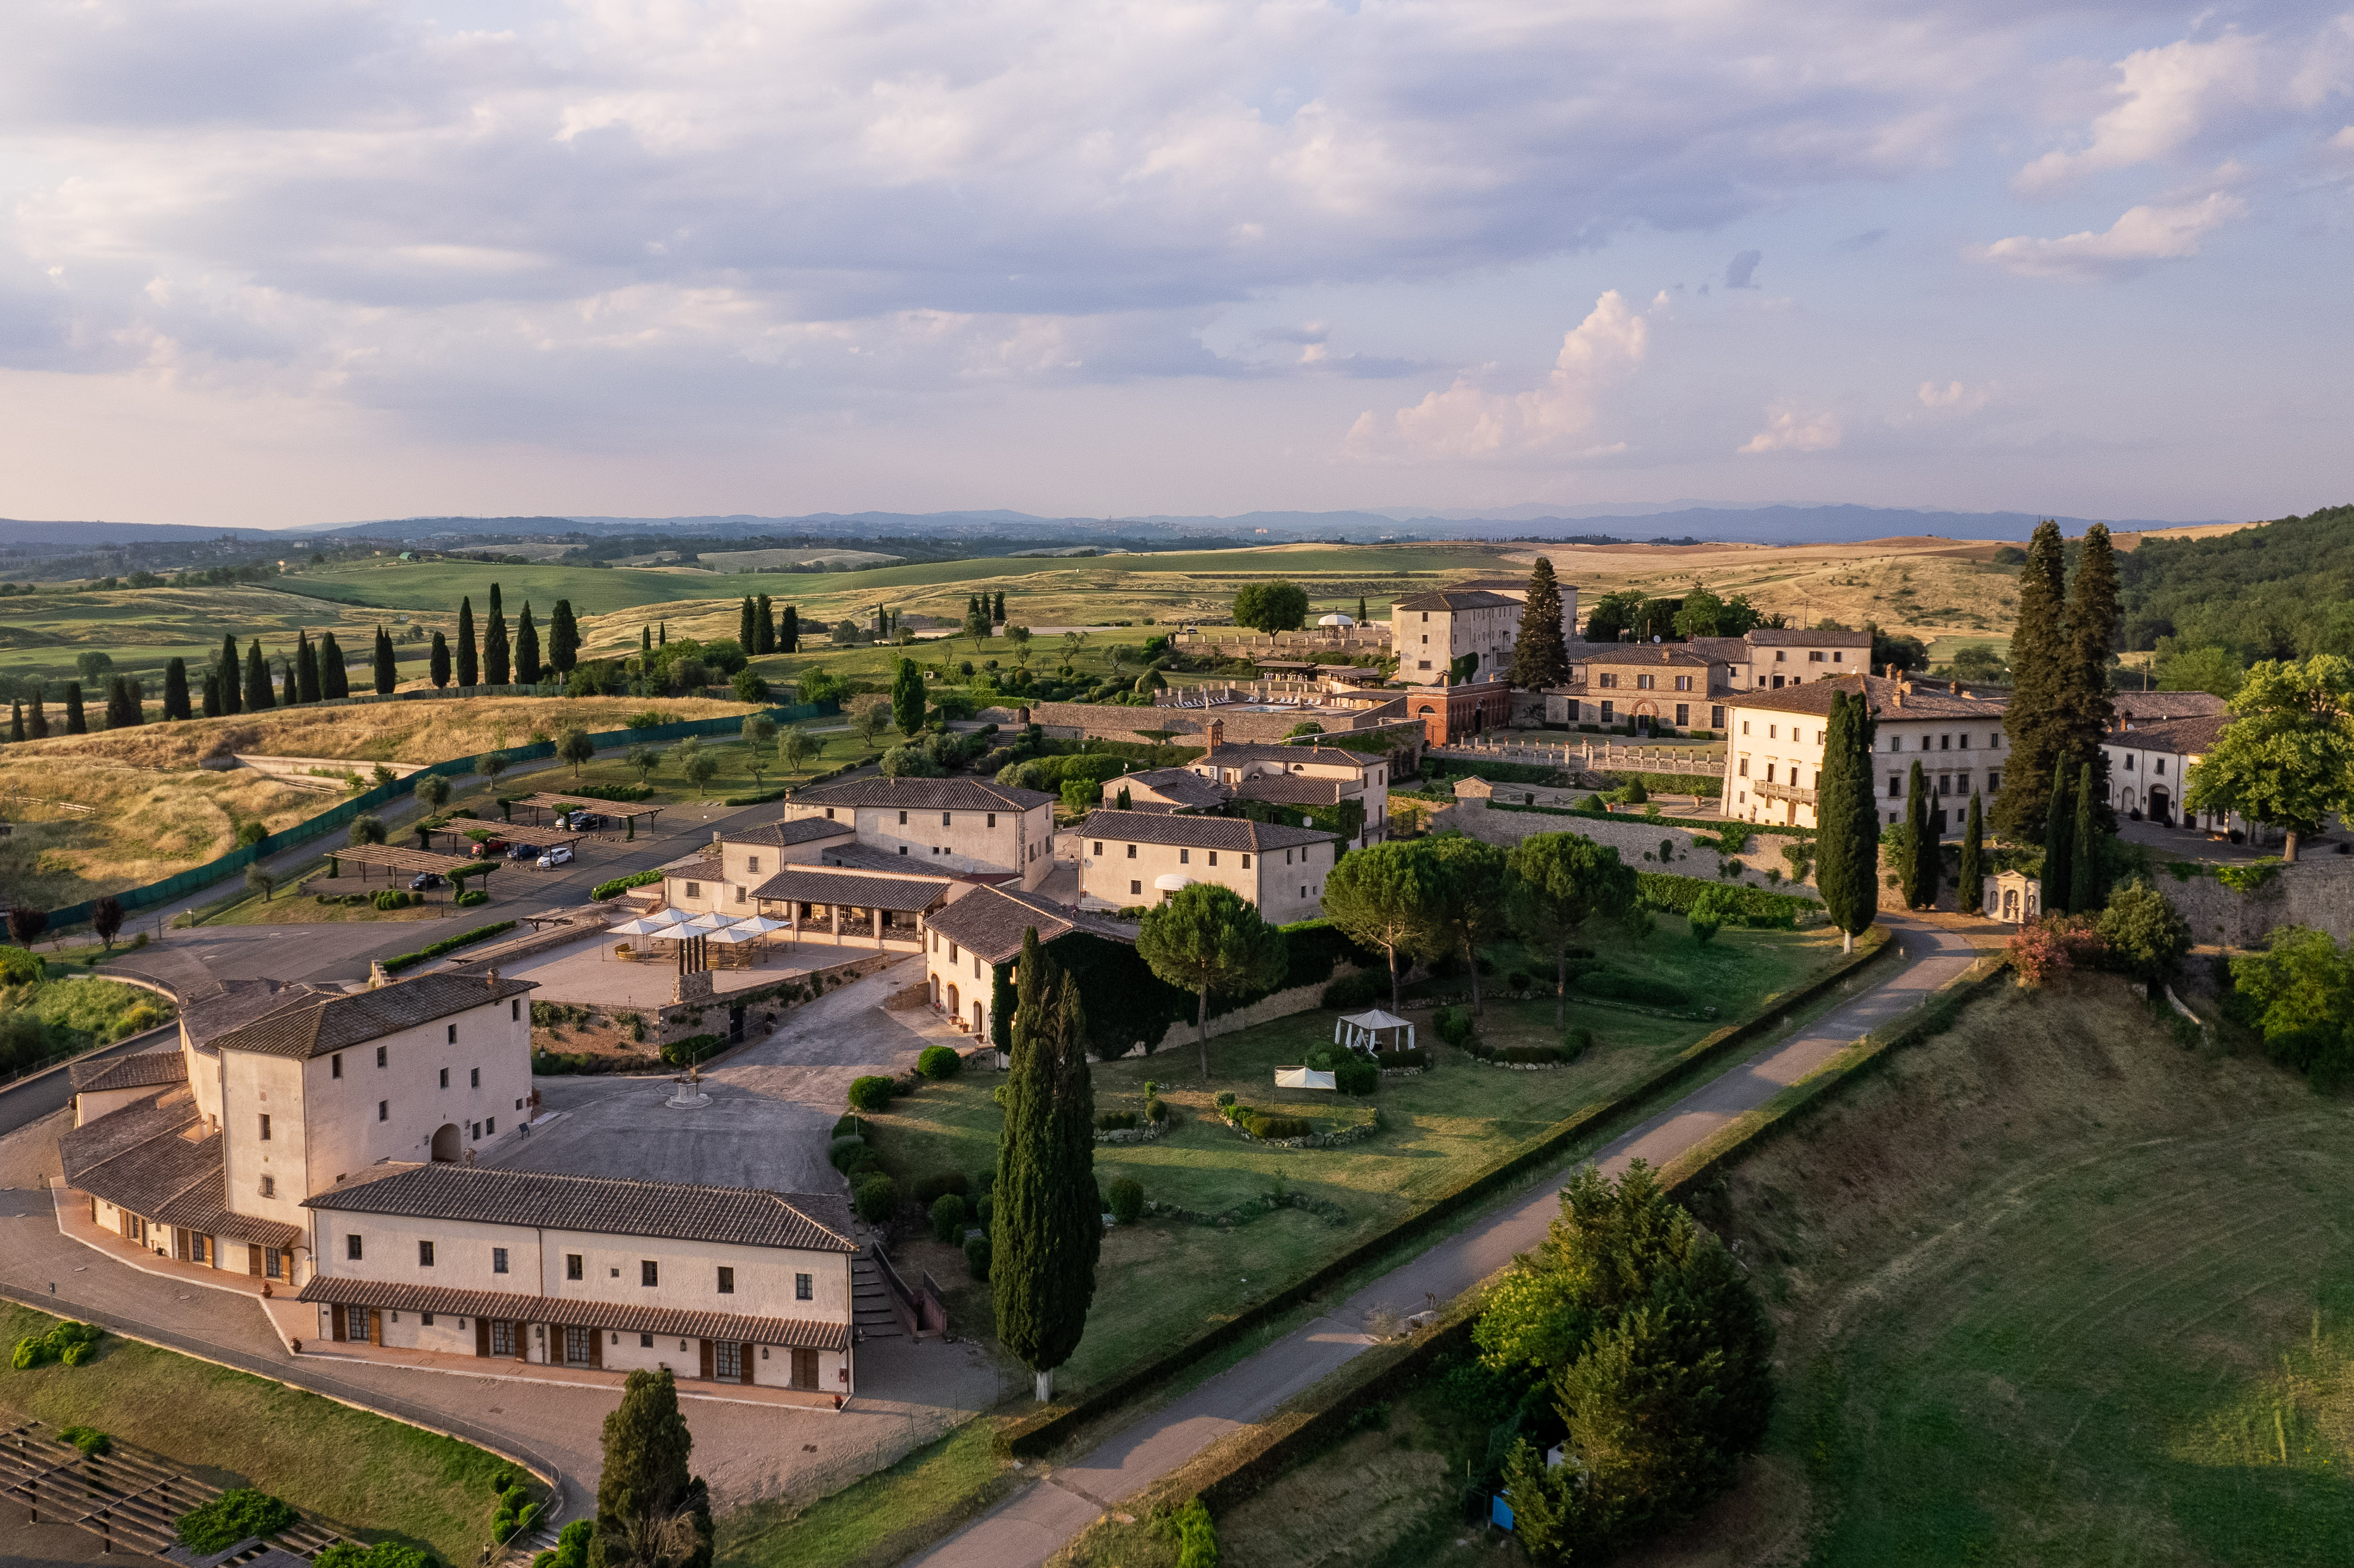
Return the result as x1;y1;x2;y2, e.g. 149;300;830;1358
989;925;1104;1403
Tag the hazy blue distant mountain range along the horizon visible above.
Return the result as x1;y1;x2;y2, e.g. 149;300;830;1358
0;502;2222;549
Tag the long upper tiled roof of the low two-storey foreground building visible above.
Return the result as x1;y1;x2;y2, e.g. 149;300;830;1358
304;1163;857;1253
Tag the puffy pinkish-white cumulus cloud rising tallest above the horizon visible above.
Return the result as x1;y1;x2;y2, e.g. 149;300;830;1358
1344;290;1650;459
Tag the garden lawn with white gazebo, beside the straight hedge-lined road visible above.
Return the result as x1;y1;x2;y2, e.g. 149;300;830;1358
847;916;1839;1391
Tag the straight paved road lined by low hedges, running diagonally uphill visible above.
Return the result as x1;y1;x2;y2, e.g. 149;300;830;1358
915;916;1977;1568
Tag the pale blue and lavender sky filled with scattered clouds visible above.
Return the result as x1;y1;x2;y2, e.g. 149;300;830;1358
0;0;2354;525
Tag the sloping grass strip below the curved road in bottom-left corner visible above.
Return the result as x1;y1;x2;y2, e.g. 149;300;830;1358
0;1302;523;1563
